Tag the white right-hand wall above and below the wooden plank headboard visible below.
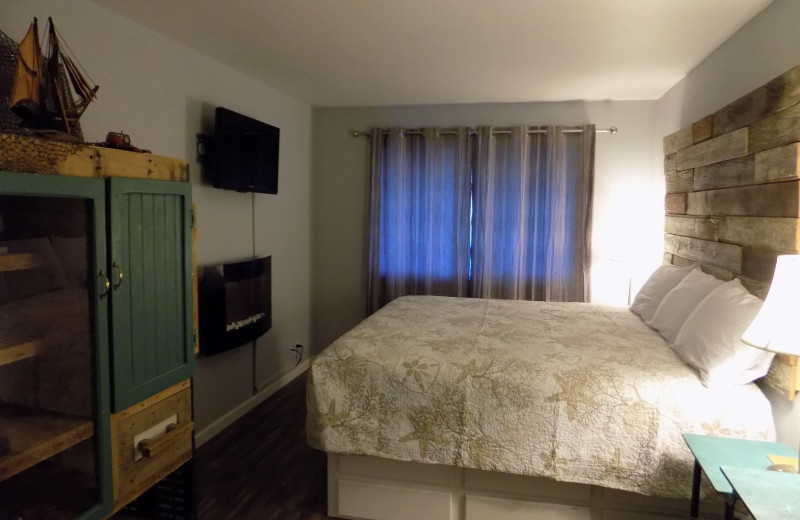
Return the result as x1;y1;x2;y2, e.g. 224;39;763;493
657;0;800;447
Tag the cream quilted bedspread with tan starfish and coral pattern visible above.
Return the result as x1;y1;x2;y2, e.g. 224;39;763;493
307;296;774;496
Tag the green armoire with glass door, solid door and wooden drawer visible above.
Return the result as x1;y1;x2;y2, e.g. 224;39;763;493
0;164;195;520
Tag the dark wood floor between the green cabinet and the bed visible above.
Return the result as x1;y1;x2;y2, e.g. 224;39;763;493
195;374;336;520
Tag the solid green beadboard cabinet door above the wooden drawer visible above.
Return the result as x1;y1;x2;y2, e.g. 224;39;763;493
107;178;194;412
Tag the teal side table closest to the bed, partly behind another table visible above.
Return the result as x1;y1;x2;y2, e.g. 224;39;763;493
683;433;798;520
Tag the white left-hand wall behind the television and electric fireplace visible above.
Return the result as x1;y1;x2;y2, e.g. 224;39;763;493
0;0;311;430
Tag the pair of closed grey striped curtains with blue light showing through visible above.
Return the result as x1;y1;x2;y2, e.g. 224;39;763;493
368;126;594;313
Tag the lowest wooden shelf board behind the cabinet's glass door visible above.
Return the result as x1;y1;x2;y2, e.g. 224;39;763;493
0;404;94;481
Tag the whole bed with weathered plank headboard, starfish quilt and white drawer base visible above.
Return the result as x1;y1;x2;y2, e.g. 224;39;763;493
307;66;800;520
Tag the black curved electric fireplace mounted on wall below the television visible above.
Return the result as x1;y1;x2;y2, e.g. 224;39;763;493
197;256;272;356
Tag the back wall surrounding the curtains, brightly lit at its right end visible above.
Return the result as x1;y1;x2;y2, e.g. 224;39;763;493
313;101;664;348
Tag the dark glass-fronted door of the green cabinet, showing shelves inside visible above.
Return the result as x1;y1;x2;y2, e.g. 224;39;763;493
0;172;113;520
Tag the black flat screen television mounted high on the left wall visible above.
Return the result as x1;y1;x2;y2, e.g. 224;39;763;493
211;107;281;194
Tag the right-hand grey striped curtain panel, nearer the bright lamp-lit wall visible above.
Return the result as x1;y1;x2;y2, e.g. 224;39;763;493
472;125;595;302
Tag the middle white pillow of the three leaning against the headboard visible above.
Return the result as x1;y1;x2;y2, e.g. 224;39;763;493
645;268;724;343
